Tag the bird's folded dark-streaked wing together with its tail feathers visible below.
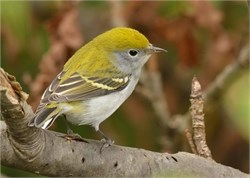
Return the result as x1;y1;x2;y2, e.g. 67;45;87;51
29;71;130;128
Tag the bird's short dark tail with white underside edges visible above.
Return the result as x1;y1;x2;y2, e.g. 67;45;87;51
28;107;61;129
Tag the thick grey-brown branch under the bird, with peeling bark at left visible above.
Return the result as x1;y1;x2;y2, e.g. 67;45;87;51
0;67;248;177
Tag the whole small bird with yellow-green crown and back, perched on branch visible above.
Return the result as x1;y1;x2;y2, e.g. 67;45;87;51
29;27;166;143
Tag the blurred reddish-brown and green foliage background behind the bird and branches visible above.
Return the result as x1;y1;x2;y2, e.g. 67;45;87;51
1;1;250;177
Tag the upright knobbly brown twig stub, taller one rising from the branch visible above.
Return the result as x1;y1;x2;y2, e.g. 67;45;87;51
190;77;212;159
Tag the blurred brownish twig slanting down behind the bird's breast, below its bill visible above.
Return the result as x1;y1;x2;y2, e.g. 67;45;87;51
137;55;174;150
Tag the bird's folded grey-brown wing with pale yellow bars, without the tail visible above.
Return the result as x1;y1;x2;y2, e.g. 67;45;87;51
36;71;130;113
